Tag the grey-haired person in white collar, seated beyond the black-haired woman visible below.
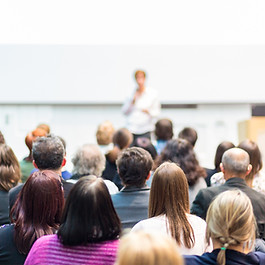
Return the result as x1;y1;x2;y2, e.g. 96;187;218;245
68;144;119;194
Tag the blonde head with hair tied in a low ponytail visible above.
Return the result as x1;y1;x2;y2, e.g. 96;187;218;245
206;190;256;265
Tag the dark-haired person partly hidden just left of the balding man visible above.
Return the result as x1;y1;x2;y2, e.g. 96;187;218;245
205;141;235;187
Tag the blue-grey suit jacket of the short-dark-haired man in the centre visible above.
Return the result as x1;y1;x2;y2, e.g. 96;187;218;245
111;186;150;229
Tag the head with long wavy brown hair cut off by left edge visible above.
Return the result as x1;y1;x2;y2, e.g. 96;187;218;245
0;144;21;191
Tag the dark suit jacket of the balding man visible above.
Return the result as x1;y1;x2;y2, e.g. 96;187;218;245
191;178;265;237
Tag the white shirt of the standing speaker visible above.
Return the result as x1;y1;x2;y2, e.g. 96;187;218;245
122;87;161;134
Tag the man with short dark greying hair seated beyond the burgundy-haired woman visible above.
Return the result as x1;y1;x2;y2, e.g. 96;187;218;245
9;135;74;209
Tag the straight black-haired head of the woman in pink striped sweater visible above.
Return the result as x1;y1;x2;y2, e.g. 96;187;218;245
58;176;121;246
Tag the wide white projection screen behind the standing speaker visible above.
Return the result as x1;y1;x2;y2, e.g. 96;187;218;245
0;44;265;104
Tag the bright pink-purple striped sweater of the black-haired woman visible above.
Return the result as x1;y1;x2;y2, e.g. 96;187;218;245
25;235;119;265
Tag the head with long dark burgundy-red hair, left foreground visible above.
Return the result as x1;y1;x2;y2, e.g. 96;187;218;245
11;170;64;254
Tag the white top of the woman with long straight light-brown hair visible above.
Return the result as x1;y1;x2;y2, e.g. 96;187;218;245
131;214;213;255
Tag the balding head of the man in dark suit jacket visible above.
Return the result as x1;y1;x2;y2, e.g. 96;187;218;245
222;148;251;176
